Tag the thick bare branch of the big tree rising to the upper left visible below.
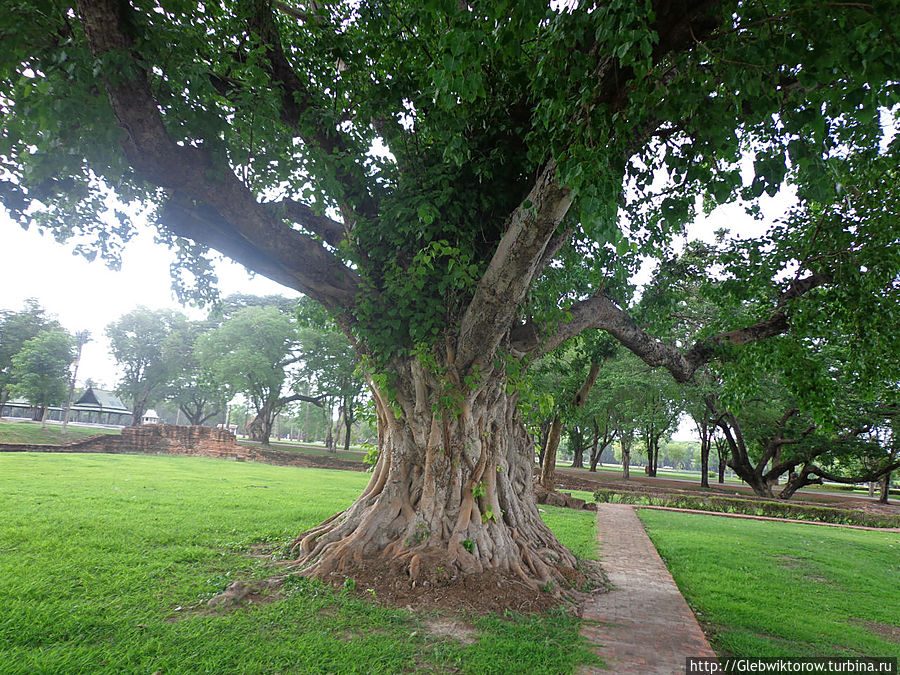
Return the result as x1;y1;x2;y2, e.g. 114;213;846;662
78;0;358;308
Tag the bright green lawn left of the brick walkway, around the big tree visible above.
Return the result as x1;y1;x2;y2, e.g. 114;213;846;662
0;453;596;675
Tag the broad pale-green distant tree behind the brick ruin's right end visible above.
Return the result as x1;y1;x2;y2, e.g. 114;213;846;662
195;305;320;445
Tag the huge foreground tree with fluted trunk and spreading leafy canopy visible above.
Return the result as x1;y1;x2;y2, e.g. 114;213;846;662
0;0;900;604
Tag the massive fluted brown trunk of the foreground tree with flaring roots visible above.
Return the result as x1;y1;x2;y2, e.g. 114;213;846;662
291;361;583;597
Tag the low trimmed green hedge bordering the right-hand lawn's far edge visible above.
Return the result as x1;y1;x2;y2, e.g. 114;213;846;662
594;488;900;527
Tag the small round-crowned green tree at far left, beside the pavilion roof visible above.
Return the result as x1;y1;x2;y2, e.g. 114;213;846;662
10;328;75;426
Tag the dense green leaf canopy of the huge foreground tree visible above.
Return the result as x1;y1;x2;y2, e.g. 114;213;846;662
0;0;900;374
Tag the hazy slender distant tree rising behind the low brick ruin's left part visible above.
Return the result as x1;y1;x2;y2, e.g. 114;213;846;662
106;307;187;424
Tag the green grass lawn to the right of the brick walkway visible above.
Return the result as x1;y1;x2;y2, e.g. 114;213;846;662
638;509;900;657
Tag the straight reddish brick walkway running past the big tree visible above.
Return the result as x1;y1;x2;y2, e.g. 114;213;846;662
580;504;715;675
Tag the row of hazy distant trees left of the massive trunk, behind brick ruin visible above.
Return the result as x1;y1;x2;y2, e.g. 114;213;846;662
0;295;366;449
